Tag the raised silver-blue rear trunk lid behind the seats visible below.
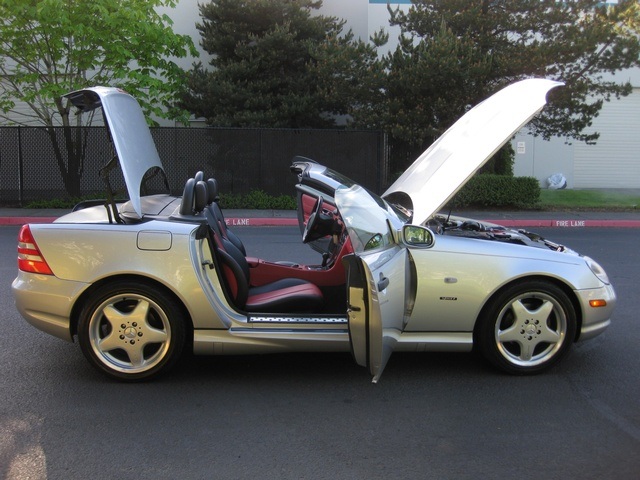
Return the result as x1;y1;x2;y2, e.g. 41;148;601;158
65;87;166;218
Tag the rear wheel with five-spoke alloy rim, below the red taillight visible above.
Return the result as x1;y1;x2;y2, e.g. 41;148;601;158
78;281;186;381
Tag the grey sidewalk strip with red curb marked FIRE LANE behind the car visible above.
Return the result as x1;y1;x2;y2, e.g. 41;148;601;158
0;208;640;228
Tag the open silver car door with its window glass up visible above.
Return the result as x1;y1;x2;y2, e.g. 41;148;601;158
335;185;411;383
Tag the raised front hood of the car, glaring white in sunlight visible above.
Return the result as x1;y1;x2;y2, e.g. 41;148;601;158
383;79;563;224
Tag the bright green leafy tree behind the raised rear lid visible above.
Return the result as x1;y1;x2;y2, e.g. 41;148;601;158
0;0;197;196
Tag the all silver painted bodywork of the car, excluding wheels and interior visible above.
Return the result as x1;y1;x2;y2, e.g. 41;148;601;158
12;81;616;379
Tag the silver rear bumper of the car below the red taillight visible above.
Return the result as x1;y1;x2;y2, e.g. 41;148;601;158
11;272;87;342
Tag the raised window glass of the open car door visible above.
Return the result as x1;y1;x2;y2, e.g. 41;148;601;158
335;184;407;252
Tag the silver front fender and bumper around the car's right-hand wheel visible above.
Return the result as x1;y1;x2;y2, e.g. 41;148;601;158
405;236;615;332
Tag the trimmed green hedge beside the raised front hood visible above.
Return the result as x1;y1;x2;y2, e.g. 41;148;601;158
449;174;540;208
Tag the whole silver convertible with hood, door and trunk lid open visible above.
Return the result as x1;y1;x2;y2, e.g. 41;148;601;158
13;79;616;382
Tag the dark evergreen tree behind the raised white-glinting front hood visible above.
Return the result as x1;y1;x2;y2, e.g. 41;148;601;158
364;0;640;171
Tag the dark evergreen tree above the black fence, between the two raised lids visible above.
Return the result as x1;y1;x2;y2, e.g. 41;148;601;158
182;0;376;128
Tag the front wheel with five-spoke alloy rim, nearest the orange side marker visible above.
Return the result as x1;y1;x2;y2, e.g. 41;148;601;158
477;280;577;375
